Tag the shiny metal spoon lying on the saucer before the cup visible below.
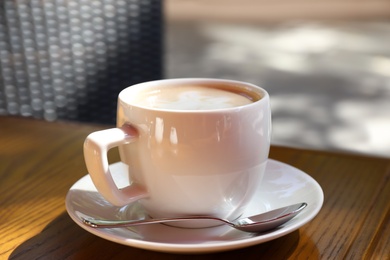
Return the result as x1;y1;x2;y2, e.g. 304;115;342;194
82;202;307;232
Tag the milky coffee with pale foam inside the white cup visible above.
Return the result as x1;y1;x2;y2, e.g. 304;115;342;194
132;85;259;110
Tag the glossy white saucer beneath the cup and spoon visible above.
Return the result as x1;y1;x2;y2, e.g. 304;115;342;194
66;160;324;253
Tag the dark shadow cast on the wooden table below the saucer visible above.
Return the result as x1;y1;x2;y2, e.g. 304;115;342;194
10;212;313;260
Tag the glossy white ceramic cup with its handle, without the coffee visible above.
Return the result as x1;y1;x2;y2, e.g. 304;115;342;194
84;78;271;226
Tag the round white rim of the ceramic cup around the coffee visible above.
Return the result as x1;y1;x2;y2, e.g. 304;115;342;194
118;78;269;113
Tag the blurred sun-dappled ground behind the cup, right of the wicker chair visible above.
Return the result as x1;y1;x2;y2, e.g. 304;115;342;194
165;0;390;157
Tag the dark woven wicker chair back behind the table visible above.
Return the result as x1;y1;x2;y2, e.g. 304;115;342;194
0;0;163;124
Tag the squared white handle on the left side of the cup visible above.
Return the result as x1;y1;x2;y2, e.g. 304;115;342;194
84;125;148;206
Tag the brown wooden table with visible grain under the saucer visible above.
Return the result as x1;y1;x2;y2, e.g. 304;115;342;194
0;116;390;259
